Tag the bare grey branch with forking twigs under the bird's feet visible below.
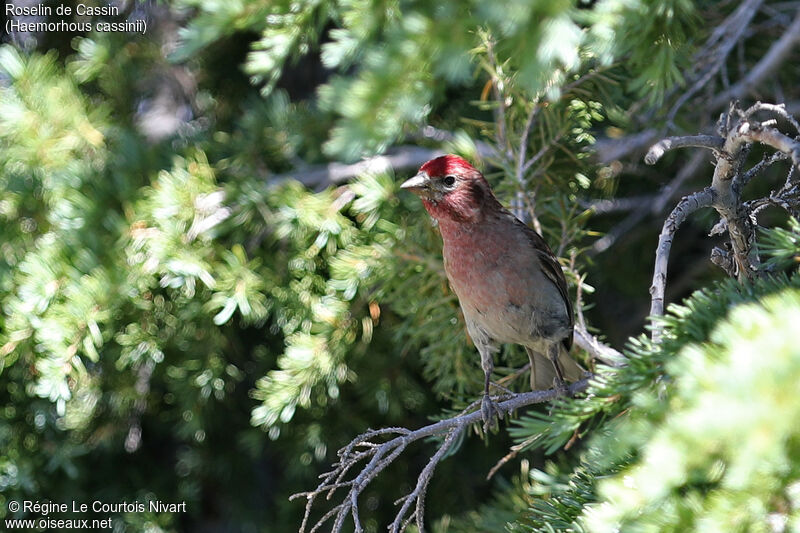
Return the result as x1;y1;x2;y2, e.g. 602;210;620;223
291;378;589;533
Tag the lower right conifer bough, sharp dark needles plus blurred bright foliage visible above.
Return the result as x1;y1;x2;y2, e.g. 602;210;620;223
511;258;800;531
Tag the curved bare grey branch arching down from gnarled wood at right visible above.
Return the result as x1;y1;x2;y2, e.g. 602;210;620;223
650;187;714;341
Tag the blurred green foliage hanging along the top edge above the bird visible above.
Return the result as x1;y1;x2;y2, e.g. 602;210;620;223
174;0;696;160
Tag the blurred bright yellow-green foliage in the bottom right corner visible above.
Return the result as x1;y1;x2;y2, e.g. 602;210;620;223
587;289;800;531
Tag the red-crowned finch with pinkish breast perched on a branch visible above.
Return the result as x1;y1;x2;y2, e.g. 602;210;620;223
400;154;585;430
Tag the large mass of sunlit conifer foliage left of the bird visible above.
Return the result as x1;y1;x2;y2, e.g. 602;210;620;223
0;40;438;530
